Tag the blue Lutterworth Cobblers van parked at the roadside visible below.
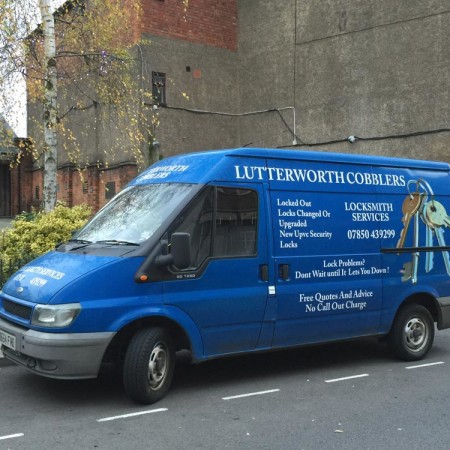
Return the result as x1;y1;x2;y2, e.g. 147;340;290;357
0;148;450;403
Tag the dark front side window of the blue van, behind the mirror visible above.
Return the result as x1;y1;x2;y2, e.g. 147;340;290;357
173;187;258;270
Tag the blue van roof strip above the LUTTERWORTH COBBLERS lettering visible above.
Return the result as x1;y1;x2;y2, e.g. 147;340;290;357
204;147;450;172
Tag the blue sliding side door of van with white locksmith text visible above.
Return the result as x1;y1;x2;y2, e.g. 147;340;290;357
270;161;389;347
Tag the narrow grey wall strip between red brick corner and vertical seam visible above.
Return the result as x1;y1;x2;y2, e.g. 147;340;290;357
238;0;295;146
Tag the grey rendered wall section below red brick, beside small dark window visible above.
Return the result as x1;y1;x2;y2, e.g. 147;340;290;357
142;36;239;156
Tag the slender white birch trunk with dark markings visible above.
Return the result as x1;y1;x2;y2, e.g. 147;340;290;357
39;0;58;211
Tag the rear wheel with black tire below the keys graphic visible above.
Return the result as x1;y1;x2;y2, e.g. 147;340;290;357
387;305;434;361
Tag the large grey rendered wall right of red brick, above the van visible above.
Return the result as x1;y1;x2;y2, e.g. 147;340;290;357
238;0;450;161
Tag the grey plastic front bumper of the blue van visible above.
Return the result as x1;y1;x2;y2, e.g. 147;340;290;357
0;318;115;379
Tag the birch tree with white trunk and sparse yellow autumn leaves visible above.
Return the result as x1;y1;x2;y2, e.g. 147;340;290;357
0;0;157;211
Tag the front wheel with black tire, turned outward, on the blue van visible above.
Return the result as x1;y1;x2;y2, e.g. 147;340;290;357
123;328;175;405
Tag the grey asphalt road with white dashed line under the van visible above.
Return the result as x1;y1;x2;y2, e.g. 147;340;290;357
0;330;450;450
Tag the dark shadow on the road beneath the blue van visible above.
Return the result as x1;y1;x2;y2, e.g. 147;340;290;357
3;339;392;408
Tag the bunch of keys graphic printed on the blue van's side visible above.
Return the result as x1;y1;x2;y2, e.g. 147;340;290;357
396;179;450;284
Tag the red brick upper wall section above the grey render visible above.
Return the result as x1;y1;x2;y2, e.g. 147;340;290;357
141;0;237;51
